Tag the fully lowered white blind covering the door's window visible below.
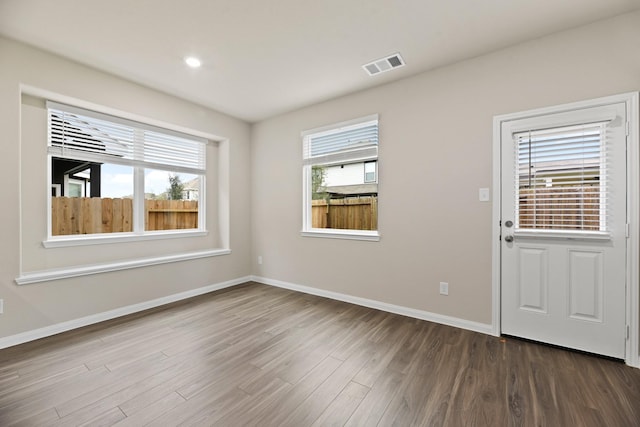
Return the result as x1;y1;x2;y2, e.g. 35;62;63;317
514;122;609;233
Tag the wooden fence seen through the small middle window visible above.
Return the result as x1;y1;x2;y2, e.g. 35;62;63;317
311;197;378;230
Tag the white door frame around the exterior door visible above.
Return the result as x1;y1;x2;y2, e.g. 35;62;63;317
491;92;640;368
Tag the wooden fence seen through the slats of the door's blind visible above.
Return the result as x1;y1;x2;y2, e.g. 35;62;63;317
519;186;600;230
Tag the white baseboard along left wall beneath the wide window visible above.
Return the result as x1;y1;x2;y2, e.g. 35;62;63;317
0;276;251;349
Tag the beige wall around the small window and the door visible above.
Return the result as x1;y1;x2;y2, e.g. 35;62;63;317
251;13;640;324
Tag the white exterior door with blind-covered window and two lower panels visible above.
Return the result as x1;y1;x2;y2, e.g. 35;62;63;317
500;103;628;359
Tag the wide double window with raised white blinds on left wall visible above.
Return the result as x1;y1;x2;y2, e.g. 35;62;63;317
47;102;206;239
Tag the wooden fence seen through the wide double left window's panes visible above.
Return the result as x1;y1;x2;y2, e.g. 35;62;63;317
51;197;198;236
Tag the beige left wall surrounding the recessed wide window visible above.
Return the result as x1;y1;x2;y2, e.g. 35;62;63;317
0;38;251;339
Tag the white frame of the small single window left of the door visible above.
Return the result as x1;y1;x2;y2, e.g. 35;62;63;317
300;114;380;242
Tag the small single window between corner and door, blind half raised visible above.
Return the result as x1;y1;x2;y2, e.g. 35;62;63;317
302;115;378;240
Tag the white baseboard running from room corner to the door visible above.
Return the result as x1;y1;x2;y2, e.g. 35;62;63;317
251;276;495;336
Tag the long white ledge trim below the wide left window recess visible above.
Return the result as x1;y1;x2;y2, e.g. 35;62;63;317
15;249;231;285
